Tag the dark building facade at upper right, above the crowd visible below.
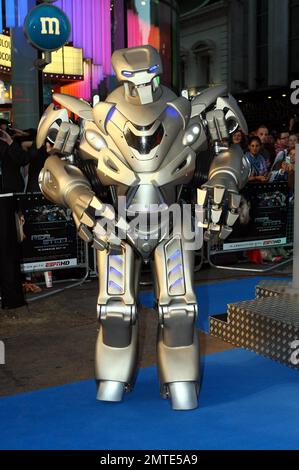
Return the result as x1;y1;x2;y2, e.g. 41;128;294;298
180;0;299;128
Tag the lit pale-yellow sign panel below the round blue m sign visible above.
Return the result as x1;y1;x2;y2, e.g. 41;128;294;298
44;46;84;78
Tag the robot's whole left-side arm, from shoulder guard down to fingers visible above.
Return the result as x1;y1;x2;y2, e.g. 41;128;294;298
36;94;120;250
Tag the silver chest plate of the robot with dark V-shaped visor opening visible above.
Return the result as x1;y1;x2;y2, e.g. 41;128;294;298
81;107;196;194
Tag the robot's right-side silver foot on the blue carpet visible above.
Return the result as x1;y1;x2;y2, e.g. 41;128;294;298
168;382;198;411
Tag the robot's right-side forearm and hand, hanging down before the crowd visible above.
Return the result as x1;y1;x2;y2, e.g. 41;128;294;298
197;145;250;240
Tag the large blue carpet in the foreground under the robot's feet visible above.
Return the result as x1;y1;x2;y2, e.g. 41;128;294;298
0;349;299;450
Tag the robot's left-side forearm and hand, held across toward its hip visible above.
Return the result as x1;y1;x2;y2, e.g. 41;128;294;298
39;155;114;250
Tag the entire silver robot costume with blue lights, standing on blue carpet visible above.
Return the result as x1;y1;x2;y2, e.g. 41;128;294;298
37;46;250;410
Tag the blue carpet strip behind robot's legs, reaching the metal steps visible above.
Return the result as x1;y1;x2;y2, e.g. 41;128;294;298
139;277;287;332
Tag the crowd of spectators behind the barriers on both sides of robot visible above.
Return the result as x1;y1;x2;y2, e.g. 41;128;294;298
0;114;299;308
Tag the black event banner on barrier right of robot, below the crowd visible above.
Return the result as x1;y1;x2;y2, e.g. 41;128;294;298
223;182;289;251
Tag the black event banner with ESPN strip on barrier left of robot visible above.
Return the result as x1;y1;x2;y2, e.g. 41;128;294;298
16;193;78;272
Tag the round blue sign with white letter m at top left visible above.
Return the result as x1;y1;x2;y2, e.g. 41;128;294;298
24;4;71;51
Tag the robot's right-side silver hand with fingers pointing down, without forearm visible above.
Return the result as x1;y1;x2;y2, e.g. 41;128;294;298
197;183;241;241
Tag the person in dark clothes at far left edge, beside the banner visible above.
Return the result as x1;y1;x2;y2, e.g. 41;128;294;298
0;130;29;308
